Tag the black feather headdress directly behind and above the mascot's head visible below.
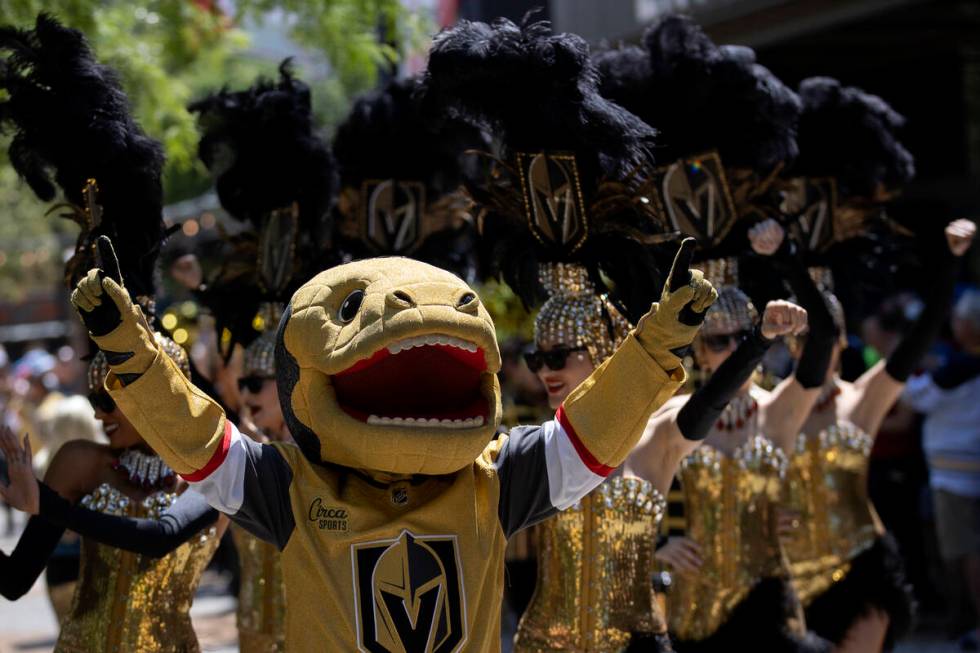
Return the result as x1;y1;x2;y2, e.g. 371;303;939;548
333;77;486;277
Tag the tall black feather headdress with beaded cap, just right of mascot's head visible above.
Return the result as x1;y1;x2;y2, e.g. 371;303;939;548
424;18;665;365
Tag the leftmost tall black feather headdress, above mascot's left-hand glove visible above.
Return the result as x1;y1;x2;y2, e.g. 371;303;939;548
0;14;166;298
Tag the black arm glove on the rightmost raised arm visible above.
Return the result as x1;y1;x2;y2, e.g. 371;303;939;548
885;253;959;383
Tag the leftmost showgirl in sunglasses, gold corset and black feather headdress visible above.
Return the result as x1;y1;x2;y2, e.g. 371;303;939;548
0;14;222;652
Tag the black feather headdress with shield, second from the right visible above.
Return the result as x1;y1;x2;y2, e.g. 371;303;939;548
595;16;800;258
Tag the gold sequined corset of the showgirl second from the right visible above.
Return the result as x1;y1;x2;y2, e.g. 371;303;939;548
667;436;787;641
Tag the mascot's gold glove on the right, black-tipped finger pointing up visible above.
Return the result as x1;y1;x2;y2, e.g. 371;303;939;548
633;238;718;371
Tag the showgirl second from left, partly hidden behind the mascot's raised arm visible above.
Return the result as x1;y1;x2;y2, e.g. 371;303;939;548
190;60;336;653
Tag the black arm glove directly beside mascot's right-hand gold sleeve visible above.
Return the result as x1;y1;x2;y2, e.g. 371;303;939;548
677;327;772;440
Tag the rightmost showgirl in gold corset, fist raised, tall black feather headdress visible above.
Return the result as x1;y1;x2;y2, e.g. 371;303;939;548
774;78;975;651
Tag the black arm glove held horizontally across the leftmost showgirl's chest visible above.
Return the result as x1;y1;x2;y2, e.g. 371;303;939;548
38;482;218;558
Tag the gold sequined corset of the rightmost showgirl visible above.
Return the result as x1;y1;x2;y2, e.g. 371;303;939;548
785;423;881;605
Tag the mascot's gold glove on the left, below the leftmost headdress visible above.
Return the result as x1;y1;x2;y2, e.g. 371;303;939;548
71;269;158;385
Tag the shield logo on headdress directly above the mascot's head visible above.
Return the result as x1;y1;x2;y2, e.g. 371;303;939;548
361;179;425;254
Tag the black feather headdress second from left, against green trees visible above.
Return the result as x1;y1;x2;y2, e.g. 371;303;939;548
189;59;337;354
